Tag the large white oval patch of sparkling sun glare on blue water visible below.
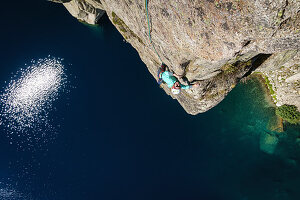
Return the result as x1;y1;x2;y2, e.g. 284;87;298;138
0;58;67;149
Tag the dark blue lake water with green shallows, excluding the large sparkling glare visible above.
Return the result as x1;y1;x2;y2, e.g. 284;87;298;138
0;1;300;200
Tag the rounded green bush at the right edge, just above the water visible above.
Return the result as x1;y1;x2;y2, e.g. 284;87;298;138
276;105;300;124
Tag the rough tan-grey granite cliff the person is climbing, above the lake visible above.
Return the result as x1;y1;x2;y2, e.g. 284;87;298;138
57;0;300;114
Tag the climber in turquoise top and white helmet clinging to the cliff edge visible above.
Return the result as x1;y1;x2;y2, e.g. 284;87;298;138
158;64;199;94
